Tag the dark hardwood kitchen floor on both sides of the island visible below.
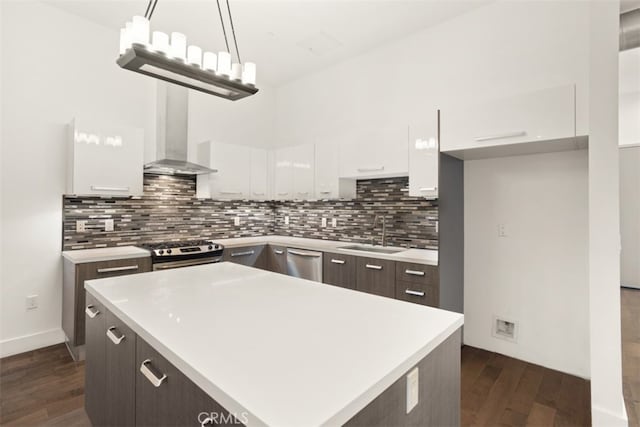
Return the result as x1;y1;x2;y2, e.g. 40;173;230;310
0;345;591;427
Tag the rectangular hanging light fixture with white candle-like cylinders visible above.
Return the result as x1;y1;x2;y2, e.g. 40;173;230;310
116;0;258;101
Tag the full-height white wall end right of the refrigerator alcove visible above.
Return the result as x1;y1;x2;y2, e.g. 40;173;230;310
589;0;627;427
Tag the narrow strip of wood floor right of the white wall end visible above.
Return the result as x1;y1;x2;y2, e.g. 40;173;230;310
620;288;640;427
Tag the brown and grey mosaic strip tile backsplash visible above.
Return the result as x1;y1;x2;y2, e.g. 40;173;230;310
62;174;438;250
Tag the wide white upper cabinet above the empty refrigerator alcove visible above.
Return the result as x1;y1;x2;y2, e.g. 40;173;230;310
440;85;576;158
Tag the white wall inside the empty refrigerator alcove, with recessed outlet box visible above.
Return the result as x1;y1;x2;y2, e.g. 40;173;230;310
464;150;589;377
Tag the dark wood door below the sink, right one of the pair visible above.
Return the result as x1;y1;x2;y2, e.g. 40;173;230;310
356;257;396;298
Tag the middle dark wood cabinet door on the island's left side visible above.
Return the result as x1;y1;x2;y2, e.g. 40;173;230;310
104;311;136;427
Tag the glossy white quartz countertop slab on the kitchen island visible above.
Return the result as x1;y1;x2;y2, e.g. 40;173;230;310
85;262;463;427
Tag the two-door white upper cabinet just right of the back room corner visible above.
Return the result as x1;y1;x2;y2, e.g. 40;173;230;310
274;144;315;200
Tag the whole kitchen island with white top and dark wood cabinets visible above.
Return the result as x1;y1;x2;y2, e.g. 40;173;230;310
85;262;463;426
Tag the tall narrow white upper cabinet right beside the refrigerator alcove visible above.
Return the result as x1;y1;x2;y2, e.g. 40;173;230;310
409;111;440;199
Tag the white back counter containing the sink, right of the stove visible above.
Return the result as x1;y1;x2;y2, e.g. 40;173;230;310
212;236;438;265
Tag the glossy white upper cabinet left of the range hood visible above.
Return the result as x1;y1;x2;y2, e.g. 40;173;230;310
67;118;144;196
